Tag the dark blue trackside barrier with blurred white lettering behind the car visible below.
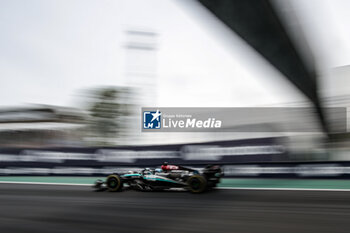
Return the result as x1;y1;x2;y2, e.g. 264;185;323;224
0;138;350;178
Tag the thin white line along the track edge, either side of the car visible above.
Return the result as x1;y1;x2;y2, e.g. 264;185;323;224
0;181;350;192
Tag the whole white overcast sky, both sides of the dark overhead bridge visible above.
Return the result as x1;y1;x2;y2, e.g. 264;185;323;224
0;0;350;108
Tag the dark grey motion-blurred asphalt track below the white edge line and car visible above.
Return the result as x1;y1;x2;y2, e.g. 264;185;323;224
0;184;350;233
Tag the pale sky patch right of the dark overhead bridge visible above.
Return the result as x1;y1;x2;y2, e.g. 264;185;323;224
291;0;350;99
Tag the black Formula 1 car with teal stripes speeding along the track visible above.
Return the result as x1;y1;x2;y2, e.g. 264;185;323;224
94;163;223;193
